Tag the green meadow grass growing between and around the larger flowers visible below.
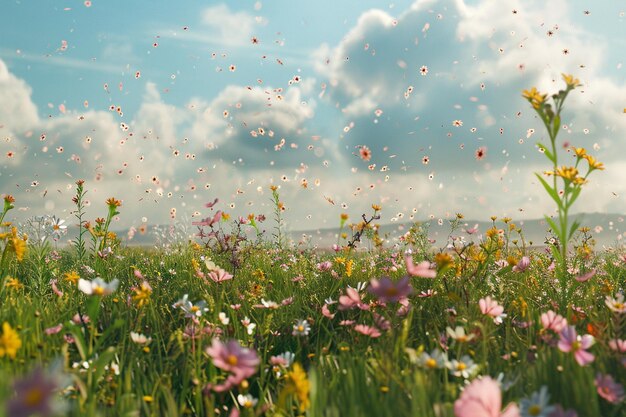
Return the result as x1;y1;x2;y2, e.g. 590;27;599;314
0;216;626;417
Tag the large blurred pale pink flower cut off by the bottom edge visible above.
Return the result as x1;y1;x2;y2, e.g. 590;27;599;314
454;377;520;417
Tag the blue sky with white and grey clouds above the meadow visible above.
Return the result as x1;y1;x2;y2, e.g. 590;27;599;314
0;0;626;239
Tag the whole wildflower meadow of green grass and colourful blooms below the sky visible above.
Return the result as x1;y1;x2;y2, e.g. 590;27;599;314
0;189;626;417
